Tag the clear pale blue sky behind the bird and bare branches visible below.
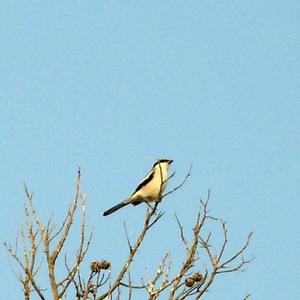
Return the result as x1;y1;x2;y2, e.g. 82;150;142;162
0;1;300;300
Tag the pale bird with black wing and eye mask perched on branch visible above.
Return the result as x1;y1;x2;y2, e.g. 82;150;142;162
103;158;173;216
